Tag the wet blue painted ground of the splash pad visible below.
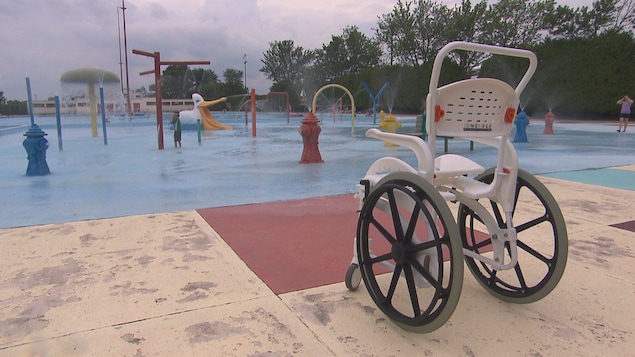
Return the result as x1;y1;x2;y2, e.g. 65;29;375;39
0;113;635;228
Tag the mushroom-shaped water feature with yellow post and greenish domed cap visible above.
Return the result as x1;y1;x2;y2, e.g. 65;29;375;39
60;67;122;137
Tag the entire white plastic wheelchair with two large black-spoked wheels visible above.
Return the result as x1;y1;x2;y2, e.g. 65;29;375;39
345;42;568;333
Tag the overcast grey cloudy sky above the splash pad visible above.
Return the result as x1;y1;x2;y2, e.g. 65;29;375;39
0;0;592;100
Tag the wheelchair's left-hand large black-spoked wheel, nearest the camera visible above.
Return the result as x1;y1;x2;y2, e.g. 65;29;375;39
357;172;463;333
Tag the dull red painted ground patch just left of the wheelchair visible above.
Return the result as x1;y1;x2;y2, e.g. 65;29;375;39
197;194;358;294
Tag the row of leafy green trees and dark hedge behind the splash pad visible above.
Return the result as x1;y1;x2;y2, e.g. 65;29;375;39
260;0;635;117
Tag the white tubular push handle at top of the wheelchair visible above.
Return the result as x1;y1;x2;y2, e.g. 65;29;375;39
429;41;538;96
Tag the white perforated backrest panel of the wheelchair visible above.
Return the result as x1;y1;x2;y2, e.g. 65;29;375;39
435;78;518;138
